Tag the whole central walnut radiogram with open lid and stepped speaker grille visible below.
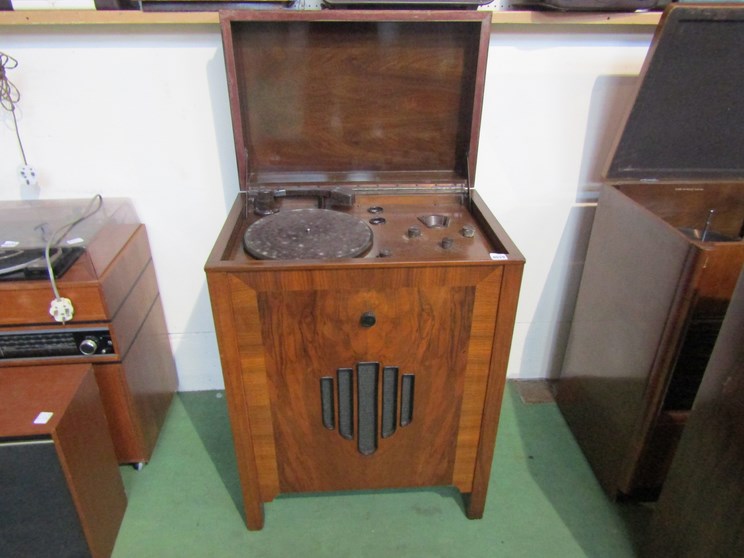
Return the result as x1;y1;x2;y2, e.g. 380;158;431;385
206;11;524;529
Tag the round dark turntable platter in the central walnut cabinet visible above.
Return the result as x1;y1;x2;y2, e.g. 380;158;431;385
243;208;372;260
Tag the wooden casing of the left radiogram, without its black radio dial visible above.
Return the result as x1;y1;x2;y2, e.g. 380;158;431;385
0;223;178;463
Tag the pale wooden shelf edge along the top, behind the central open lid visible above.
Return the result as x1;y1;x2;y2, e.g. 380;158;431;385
0;10;661;26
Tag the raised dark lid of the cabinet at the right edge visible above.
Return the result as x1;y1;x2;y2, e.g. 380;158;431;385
606;4;744;182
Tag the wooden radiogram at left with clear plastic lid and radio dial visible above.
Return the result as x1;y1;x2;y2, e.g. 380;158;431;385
0;199;178;465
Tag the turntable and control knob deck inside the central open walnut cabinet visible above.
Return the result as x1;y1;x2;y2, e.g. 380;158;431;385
242;194;507;261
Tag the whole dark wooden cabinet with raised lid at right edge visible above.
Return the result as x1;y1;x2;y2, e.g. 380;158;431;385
557;5;744;504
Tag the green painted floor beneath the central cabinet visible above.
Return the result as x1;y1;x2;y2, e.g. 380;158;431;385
114;382;649;558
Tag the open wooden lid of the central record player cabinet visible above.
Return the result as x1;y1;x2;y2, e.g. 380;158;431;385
221;10;490;190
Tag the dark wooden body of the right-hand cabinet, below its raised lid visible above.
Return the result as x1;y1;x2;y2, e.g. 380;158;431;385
557;183;744;498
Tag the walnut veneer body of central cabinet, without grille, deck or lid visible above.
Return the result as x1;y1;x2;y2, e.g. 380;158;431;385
207;192;523;529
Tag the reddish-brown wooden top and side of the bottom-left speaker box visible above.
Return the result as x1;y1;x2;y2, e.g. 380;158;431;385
0;364;126;558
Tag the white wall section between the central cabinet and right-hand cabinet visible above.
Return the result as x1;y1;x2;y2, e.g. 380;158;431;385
476;26;653;378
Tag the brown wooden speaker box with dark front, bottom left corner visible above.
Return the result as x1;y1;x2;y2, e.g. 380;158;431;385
0;364;127;558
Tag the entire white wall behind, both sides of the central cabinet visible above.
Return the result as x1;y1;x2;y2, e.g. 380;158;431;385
0;20;653;390
